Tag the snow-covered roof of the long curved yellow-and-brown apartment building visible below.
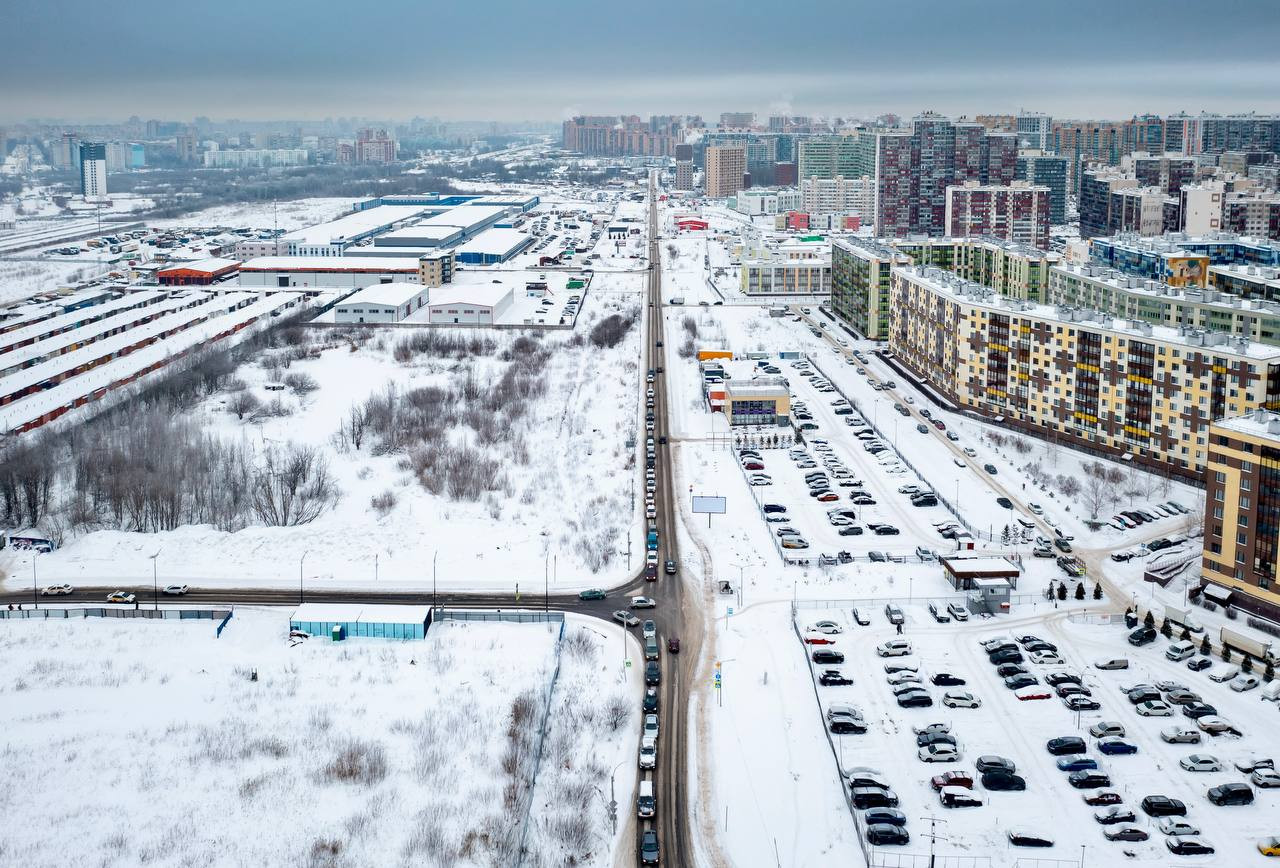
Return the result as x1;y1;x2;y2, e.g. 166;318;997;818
895;265;1280;364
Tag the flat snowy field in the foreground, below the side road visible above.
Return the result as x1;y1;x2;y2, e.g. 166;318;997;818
0;608;640;867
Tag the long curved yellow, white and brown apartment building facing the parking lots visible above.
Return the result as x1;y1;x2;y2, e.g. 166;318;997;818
888;266;1280;478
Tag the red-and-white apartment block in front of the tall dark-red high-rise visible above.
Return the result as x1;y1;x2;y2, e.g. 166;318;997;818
946;181;1050;250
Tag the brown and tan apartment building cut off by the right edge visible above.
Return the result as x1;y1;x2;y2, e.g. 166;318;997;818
1201;408;1280;620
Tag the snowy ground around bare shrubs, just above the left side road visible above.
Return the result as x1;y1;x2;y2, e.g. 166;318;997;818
4;274;643;593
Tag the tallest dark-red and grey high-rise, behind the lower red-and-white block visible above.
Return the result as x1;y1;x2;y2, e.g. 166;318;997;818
865;113;1018;237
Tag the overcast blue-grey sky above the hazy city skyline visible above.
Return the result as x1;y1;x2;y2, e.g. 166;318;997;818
10;0;1280;120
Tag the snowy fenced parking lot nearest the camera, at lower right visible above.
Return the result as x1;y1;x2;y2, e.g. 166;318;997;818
795;604;1280;864
